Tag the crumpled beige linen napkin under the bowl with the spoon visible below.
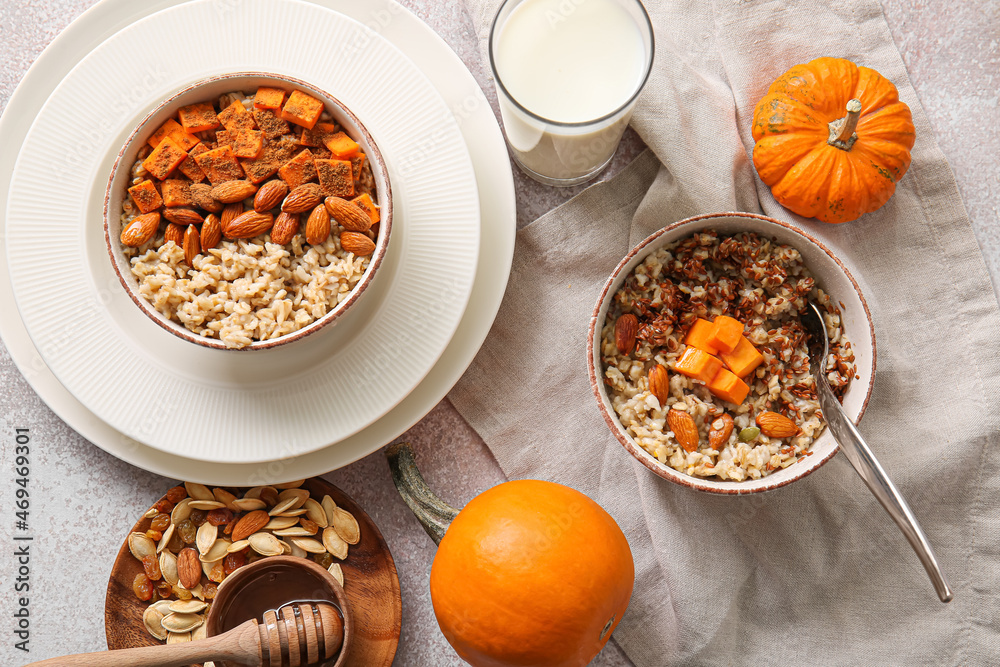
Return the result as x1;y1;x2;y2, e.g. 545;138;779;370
450;0;1000;666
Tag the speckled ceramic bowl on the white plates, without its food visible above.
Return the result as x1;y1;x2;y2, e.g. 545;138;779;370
104;72;393;351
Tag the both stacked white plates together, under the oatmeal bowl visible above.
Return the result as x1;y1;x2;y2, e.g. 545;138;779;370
0;0;515;485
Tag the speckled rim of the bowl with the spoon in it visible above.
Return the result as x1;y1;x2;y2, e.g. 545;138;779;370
587;211;877;496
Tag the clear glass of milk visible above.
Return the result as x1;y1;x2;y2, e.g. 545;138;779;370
489;0;653;186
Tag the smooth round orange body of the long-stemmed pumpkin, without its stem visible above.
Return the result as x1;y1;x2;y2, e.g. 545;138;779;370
430;480;635;667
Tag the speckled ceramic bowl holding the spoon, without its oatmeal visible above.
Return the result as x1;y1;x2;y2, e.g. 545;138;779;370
587;213;875;495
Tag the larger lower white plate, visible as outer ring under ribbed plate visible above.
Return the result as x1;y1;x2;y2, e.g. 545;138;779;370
0;0;515;485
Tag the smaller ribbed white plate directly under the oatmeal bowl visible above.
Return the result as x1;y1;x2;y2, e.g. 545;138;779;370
6;0;480;463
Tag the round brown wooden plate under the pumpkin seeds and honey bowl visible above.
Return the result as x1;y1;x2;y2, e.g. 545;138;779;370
104;477;403;667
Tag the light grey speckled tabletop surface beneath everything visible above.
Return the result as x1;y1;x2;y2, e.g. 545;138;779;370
0;0;1000;666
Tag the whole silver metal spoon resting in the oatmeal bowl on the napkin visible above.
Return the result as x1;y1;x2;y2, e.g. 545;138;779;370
802;302;952;602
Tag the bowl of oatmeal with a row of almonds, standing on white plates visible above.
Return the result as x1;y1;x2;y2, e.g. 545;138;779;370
104;72;392;350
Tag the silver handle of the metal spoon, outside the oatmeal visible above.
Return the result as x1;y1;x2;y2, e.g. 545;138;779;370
816;376;952;602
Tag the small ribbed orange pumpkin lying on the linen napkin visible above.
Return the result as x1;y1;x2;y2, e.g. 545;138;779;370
753;58;915;222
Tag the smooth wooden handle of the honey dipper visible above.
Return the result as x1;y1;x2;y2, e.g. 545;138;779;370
25;620;262;667
